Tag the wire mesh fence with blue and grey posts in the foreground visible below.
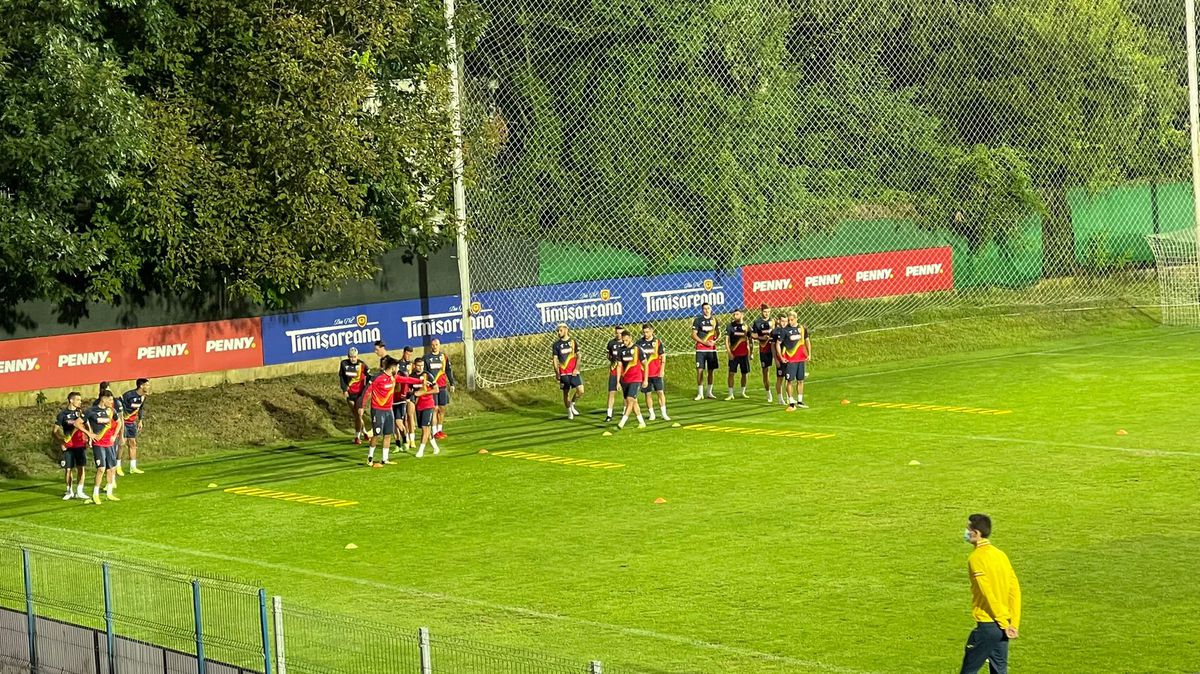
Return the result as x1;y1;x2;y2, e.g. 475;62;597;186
0;540;634;674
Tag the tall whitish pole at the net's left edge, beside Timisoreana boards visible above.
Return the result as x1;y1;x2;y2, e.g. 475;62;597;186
445;0;475;391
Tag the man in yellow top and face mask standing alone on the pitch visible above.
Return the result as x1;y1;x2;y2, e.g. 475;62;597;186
961;514;1021;674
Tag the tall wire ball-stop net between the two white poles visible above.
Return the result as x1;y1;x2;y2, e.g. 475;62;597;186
464;0;1192;385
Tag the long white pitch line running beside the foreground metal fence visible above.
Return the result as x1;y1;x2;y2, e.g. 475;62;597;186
0;517;882;674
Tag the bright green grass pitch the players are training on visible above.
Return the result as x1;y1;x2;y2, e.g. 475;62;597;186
0;312;1200;673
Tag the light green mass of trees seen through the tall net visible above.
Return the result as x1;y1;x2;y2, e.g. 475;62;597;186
468;0;1187;276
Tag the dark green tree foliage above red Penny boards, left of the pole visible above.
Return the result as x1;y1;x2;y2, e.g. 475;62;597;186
0;0;480;320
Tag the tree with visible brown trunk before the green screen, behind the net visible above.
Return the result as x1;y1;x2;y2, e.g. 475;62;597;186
888;0;1186;277
